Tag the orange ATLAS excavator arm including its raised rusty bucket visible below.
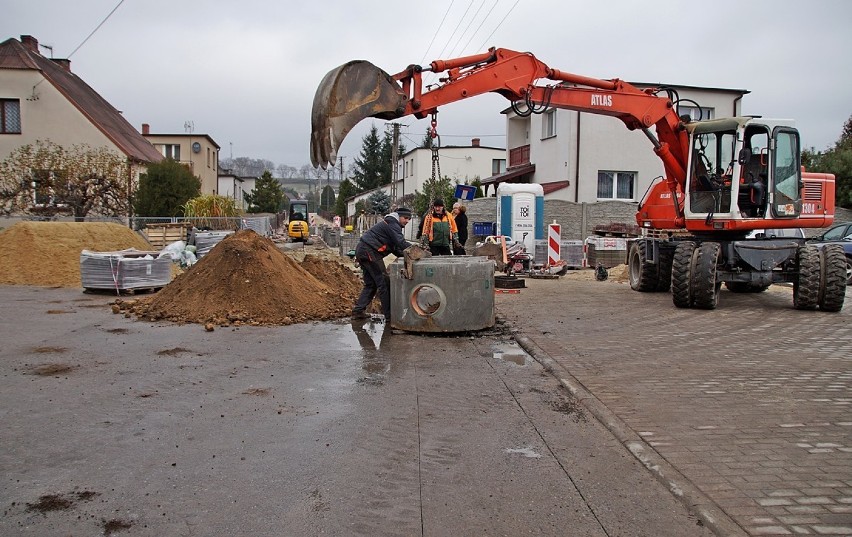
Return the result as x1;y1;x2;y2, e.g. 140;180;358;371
311;48;689;211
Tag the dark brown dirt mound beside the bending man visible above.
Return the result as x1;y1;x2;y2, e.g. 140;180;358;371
114;230;361;328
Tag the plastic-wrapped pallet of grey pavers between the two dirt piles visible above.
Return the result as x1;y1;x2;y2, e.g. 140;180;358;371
80;248;172;291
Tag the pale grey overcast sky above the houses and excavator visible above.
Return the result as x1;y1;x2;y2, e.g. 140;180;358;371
0;0;852;171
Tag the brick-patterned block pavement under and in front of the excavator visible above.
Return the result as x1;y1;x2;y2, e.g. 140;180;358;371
497;274;852;536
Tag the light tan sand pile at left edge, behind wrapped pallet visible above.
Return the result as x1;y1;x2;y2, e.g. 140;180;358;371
0;222;151;287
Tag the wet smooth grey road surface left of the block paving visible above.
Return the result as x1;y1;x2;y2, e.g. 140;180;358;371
0;286;712;537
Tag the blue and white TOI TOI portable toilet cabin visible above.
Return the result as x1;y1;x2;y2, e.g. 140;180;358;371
497;183;544;253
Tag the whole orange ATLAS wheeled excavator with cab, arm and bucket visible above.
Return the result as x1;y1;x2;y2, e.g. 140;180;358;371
311;48;846;312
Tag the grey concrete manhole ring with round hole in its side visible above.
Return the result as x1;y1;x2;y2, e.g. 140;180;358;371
389;256;494;332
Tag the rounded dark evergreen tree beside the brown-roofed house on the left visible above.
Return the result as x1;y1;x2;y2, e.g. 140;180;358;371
133;159;201;216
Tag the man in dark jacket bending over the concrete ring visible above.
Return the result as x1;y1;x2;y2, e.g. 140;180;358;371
352;207;411;322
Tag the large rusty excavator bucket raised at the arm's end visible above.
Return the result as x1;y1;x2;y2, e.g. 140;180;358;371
311;60;407;169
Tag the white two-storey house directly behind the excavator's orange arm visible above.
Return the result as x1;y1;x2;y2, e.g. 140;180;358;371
490;83;749;203
